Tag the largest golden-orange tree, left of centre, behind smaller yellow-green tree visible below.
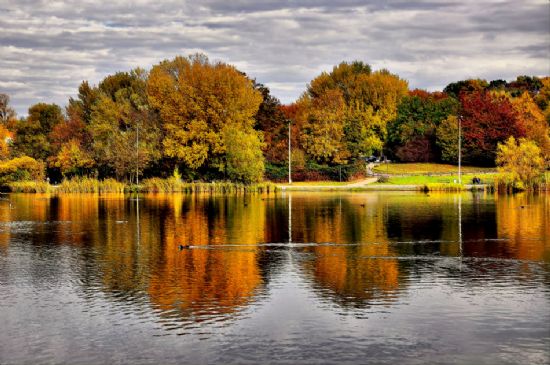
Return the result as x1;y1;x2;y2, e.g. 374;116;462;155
147;55;262;178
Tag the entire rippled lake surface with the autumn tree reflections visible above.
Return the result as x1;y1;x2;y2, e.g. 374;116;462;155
0;192;550;364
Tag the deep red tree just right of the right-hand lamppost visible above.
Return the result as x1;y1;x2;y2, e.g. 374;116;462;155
460;91;525;165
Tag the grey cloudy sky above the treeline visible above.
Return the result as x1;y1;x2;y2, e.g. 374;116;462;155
0;0;550;115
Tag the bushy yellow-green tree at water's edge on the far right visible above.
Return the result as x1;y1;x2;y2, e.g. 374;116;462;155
496;137;545;190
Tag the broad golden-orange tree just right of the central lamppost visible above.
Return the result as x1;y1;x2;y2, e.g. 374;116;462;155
302;61;407;163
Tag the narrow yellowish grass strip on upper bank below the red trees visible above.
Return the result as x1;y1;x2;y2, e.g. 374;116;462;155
373;163;496;175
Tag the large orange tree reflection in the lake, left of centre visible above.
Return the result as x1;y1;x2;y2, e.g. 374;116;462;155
148;195;265;321
